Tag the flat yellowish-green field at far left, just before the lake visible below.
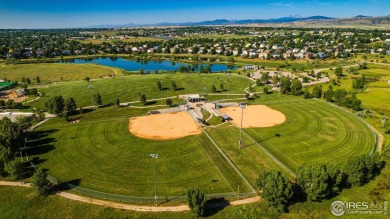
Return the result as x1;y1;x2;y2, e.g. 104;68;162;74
0;63;122;83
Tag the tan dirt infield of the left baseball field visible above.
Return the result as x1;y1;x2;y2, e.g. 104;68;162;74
129;112;202;140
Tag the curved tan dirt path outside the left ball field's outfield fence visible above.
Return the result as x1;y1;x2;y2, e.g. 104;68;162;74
0;181;261;212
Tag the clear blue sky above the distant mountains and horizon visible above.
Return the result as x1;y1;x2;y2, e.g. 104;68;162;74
0;0;390;29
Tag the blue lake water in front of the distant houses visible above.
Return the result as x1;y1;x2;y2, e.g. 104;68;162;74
61;57;237;73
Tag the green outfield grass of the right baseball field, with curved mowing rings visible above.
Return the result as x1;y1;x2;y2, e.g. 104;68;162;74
244;98;375;171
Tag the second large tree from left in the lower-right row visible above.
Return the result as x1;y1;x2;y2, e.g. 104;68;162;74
297;164;332;201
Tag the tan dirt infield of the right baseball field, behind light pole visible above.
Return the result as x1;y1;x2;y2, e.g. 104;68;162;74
219;105;286;128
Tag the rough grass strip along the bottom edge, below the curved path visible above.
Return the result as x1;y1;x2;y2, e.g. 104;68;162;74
0;167;390;219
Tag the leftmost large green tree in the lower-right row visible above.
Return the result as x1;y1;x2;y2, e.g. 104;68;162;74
257;170;292;212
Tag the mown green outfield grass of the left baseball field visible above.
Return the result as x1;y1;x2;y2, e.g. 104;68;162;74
25;108;241;197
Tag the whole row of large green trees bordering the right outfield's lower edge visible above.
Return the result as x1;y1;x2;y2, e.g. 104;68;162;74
257;154;384;212
